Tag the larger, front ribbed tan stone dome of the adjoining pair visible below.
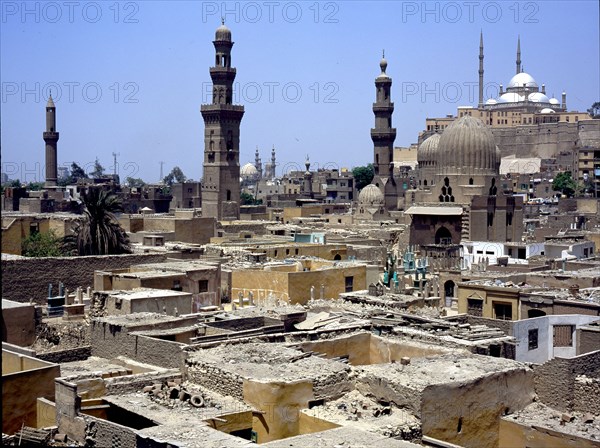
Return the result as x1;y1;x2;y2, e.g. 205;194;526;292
437;115;500;174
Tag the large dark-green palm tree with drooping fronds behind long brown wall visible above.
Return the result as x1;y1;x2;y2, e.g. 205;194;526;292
66;188;131;255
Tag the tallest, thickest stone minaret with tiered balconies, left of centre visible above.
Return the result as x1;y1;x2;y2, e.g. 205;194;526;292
200;21;244;220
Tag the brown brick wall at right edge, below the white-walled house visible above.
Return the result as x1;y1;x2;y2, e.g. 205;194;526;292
534;351;600;412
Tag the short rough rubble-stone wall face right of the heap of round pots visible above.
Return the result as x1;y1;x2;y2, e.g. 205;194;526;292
186;360;244;400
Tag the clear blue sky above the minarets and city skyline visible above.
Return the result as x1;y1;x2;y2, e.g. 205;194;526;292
0;1;600;182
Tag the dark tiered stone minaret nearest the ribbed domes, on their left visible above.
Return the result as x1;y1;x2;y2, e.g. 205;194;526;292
371;52;396;178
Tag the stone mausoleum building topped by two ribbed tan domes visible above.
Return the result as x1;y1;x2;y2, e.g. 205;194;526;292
405;115;523;258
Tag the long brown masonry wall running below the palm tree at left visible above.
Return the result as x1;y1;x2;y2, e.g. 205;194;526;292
2;254;167;305
